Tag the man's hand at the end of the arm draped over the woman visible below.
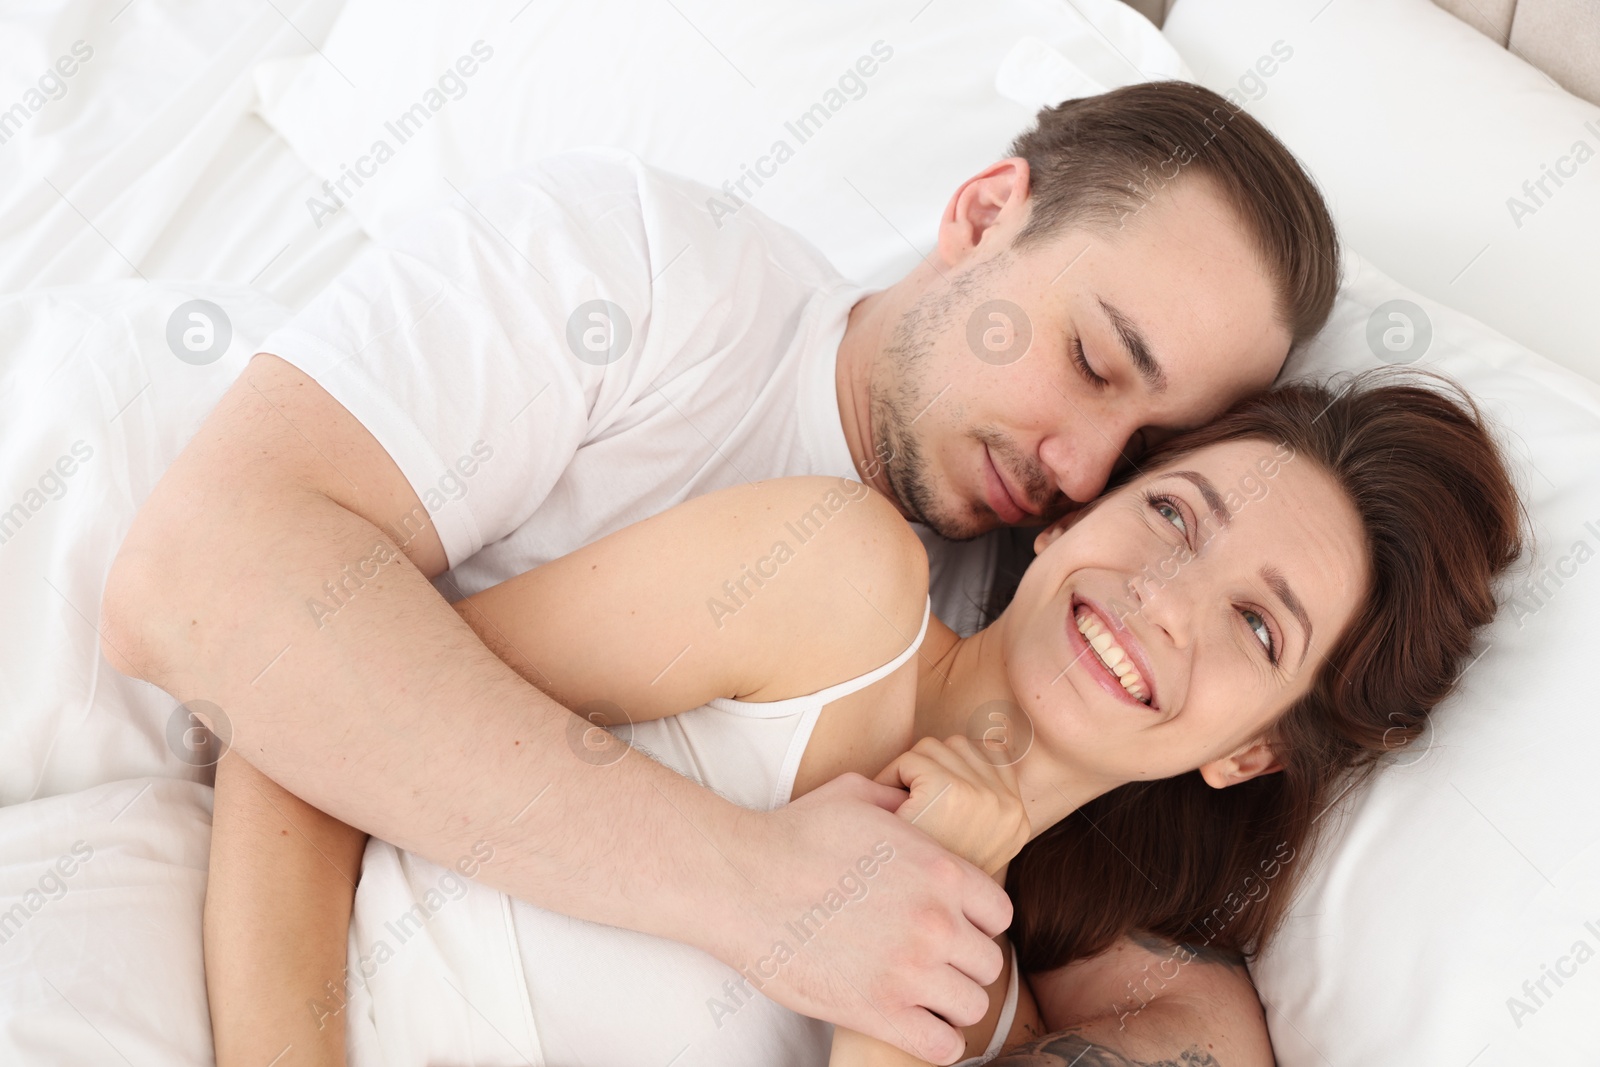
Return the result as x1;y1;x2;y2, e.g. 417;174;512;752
732;774;1011;1064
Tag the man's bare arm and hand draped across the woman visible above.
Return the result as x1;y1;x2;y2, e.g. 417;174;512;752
101;354;1011;1062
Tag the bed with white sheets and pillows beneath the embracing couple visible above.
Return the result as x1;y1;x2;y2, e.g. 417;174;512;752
0;0;1600;1067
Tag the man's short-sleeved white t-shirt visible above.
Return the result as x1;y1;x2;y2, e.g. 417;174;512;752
262;149;995;633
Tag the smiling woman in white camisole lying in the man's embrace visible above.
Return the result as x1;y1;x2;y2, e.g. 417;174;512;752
206;369;1520;1067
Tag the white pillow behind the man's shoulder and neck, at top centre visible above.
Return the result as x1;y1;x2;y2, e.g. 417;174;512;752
258;0;1182;285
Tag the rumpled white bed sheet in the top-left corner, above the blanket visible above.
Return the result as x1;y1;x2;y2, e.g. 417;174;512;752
0;0;368;309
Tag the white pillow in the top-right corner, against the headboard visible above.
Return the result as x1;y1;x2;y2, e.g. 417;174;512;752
1165;0;1600;388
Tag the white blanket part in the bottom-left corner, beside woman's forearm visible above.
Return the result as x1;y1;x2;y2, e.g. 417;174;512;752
0;777;213;1067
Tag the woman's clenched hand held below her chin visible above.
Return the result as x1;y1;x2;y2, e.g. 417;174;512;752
875;736;1032;875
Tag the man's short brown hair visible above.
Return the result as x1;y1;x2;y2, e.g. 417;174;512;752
1011;82;1339;344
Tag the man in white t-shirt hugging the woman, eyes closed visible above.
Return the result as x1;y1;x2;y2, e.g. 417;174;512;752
102;83;1338;1062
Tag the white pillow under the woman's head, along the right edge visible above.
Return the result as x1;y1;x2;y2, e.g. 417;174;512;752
1253;254;1600;1067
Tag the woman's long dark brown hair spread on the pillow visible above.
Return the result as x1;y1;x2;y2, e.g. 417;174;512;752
1006;371;1523;973
